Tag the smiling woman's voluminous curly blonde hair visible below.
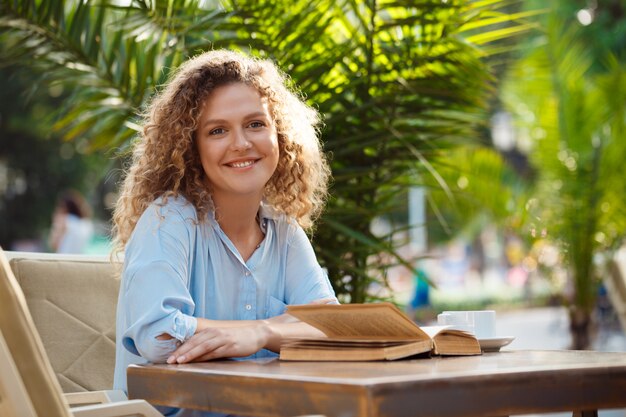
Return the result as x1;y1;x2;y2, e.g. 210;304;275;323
113;50;330;250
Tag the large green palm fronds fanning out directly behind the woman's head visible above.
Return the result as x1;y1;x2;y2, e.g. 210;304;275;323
0;0;532;302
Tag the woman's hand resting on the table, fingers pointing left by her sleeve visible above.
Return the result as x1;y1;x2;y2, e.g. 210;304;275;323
167;321;269;364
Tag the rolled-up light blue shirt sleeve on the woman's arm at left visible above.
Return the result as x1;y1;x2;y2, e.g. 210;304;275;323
119;202;197;363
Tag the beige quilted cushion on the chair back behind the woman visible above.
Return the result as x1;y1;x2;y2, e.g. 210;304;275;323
9;253;120;392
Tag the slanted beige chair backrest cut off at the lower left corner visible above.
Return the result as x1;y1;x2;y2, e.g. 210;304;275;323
0;248;70;417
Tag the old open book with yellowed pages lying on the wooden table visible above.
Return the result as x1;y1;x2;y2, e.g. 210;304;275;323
280;303;481;361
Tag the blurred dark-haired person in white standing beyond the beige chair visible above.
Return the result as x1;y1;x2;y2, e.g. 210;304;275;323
48;190;93;253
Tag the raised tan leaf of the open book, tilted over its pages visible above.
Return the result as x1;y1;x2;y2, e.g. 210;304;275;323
287;303;429;339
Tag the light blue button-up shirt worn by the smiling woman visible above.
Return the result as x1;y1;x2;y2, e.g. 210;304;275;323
114;197;335;412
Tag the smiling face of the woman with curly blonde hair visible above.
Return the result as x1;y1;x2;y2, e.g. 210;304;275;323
196;83;279;202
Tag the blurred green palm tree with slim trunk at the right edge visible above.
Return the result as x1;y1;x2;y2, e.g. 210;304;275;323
505;15;626;312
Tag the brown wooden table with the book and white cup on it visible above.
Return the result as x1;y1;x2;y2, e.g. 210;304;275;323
128;351;626;417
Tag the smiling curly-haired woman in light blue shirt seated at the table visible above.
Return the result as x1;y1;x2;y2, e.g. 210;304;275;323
114;51;336;406
